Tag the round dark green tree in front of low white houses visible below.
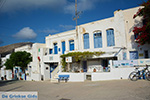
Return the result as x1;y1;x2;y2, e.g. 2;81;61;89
5;51;32;71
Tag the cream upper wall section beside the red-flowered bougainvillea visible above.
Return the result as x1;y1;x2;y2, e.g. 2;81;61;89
122;6;150;59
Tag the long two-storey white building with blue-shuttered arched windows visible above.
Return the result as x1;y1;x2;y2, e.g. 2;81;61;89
10;7;150;81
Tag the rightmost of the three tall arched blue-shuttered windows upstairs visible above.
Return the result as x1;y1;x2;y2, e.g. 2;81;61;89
106;29;115;47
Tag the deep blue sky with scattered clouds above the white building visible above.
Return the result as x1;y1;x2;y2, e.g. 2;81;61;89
0;0;146;46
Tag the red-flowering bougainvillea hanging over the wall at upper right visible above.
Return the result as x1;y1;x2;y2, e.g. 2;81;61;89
133;0;150;45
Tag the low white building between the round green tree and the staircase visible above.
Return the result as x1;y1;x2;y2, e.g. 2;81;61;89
15;43;45;81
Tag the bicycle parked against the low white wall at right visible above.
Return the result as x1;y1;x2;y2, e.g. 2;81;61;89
129;65;150;81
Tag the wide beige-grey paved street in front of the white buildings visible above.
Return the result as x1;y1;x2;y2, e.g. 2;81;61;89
0;80;150;100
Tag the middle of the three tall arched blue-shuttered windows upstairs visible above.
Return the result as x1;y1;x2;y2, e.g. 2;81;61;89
94;31;102;48
